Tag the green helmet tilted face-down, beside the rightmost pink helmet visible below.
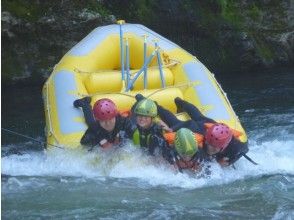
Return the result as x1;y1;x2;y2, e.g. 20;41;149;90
175;128;198;157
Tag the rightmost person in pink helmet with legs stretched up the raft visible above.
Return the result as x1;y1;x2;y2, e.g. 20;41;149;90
154;97;248;166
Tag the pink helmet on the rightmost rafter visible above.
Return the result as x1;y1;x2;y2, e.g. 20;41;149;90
205;123;233;151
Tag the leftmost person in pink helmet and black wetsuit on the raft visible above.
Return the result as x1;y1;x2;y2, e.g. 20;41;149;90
73;97;134;149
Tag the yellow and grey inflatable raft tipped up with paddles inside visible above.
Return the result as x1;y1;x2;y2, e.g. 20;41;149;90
43;22;247;148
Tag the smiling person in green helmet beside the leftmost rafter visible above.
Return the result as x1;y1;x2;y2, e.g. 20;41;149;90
132;98;167;155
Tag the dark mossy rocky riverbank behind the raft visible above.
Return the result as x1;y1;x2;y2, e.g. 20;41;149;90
1;0;294;85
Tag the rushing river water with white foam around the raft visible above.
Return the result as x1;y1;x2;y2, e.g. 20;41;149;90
1;69;294;219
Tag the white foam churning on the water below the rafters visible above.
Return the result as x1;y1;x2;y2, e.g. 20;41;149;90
2;137;294;188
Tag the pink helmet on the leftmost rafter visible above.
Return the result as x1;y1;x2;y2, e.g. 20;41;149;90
93;98;117;121
